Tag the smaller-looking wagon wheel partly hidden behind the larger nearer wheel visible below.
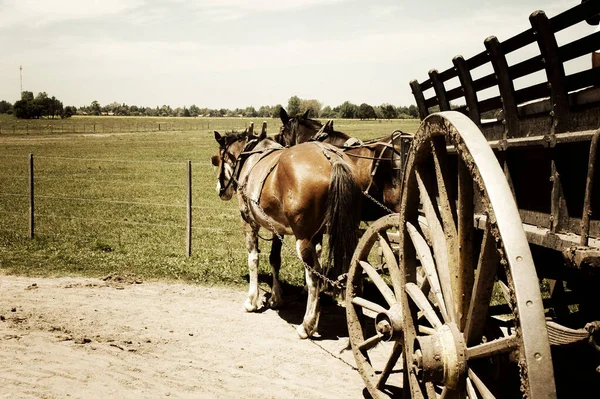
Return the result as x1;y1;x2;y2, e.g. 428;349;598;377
346;213;402;398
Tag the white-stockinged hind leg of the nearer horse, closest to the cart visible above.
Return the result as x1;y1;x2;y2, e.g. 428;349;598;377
296;240;321;339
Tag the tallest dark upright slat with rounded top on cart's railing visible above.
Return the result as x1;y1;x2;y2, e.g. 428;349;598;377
529;11;571;133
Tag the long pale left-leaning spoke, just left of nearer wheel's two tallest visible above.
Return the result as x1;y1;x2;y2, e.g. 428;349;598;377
415;170;455;321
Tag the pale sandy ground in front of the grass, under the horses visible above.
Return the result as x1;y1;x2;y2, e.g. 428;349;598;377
0;275;364;398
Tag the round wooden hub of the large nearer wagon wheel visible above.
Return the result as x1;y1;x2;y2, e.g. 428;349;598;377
412;323;467;390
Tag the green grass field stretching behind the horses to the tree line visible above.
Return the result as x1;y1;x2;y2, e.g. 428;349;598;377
0;117;419;285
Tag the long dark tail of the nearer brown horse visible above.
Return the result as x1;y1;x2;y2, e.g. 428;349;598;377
325;161;362;277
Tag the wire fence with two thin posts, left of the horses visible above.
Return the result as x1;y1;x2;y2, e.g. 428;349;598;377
0;155;245;256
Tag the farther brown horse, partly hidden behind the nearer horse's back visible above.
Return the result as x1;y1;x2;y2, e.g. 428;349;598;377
275;108;412;221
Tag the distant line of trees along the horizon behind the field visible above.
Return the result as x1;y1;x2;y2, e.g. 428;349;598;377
0;91;419;119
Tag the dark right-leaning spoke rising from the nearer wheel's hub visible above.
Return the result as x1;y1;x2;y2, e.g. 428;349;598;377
464;224;500;345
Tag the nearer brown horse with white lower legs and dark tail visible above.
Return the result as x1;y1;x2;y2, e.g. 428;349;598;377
212;124;361;338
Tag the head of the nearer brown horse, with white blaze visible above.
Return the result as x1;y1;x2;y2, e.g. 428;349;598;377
211;130;248;201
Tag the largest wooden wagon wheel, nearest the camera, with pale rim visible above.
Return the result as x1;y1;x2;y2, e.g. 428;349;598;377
399;112;556;399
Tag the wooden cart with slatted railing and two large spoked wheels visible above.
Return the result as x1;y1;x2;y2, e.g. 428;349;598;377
346;1;600;399
